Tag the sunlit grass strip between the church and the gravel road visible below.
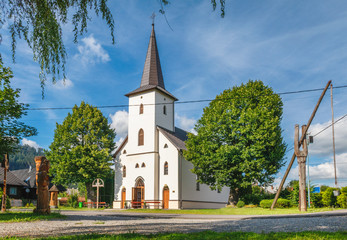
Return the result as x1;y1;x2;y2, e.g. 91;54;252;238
122;207;337;215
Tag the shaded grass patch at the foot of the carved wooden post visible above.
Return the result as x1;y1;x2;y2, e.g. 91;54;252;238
0;212;66;222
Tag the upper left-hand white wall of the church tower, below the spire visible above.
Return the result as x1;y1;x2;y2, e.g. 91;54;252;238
128;91;156;154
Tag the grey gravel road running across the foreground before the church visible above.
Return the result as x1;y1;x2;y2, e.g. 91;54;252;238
0;211;347;237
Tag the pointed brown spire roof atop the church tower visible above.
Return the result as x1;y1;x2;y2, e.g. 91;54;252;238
125;24;177;101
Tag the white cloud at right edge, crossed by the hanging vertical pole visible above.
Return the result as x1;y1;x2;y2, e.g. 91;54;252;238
309;118;347;156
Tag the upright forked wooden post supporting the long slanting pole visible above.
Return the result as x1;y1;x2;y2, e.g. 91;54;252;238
294;124;308;211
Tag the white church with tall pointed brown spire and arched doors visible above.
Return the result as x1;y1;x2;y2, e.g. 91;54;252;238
113;24;229;209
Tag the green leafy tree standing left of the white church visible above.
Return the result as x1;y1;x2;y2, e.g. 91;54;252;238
46;102;116;200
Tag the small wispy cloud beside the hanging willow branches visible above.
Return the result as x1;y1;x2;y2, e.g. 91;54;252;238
75;35;111;65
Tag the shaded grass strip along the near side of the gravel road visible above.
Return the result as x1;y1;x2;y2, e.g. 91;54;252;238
4;231;347;240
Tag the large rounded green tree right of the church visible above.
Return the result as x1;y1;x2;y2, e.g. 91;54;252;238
184;81;286;202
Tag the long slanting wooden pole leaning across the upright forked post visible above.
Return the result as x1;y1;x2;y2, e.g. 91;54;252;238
271;80;331;209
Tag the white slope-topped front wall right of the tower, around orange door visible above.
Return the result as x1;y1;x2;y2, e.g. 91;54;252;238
158;132;179;202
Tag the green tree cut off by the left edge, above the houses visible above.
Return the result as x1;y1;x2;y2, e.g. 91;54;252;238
0;57;37;154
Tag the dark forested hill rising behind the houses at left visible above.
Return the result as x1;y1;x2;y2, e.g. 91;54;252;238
9;145;45;170
